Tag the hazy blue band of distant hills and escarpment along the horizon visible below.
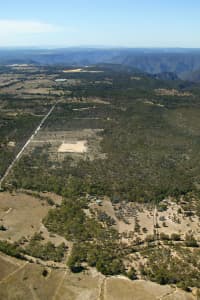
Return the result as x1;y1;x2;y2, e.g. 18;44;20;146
0;48;200;79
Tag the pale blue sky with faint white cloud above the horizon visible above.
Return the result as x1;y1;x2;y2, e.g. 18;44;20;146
0;0;200;48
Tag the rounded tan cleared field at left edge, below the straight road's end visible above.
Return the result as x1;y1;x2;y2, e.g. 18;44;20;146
0;193;50;241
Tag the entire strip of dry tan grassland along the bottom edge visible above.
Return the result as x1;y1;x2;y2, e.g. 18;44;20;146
0;255;196;300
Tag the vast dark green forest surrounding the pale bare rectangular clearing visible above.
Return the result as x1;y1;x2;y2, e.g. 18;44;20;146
6;70;200;202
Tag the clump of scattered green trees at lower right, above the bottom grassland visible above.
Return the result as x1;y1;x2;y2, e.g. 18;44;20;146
140;246;200;291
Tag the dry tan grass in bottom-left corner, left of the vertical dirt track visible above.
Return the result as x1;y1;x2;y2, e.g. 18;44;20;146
0;256;102;300
